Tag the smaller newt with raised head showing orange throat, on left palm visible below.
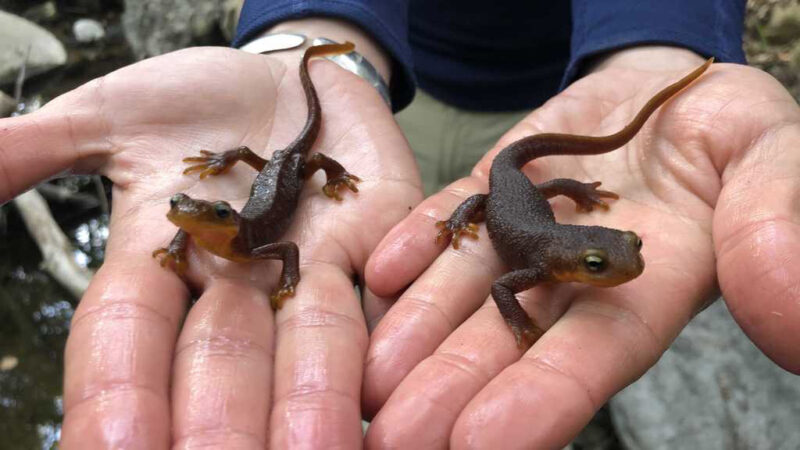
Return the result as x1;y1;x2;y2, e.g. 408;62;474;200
153;42;361;309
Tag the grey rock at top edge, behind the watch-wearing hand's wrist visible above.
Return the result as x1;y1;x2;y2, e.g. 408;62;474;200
122;0;229;58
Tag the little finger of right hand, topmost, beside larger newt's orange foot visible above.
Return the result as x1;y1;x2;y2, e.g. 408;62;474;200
365;177;486;297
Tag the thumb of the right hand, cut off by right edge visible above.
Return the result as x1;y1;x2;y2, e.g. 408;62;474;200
714;122;800;374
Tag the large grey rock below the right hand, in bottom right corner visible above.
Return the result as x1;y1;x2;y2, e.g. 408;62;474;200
611;301;800;450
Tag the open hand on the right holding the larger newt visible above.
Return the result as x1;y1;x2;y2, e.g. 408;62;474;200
363;48;800;448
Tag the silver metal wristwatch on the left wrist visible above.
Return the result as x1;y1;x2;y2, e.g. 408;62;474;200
239;33;392;109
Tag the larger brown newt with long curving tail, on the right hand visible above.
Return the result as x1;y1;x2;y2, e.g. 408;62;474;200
436;58;714;350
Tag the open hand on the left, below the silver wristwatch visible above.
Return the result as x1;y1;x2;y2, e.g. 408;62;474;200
0;42;421;449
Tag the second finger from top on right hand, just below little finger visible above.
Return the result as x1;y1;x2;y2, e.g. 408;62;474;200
363;182;501;416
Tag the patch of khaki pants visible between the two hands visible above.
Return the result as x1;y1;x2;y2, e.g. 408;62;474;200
395;90;529;196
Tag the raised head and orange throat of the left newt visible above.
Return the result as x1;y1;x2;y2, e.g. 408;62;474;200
167;194;239;256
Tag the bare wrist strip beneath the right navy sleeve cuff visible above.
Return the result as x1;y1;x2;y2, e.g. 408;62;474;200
584;45;705;75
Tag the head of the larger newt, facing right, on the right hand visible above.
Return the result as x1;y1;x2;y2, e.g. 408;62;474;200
552;226;644;287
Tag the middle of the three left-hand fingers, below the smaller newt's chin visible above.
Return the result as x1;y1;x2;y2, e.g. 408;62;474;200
172;279;274;448
